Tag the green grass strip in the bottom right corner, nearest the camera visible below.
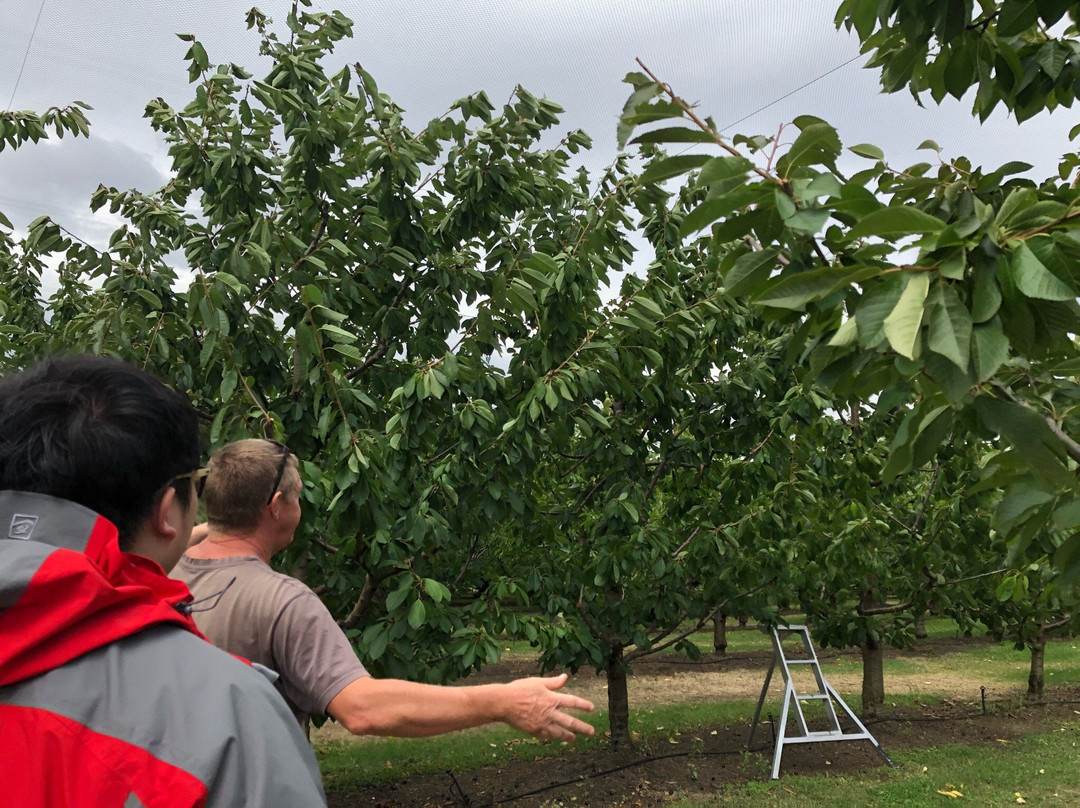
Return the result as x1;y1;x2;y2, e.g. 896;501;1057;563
673;722;1080;808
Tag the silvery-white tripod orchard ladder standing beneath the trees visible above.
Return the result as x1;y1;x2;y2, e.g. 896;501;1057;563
746;625;896;780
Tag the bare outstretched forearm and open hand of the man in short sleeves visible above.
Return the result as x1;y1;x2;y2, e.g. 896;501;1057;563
326;673;595;741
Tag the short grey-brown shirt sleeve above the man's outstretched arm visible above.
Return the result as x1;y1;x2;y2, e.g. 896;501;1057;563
270;584;369;715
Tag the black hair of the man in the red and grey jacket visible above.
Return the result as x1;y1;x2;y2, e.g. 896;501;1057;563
0;355;199;549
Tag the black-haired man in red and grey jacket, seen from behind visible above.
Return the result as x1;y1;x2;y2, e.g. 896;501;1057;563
0;356;325;808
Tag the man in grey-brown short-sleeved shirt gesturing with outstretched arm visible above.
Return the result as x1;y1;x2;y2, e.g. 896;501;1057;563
179;440;594;741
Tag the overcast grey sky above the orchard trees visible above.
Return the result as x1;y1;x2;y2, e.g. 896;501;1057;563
0;0;1075;242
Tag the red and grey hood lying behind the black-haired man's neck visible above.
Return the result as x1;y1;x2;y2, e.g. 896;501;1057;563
0;491;202;686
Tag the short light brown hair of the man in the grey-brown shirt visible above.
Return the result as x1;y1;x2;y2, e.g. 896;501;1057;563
202;439;301;533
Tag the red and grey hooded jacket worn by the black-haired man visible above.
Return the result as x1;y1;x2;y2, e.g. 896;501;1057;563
0;491;325;808
